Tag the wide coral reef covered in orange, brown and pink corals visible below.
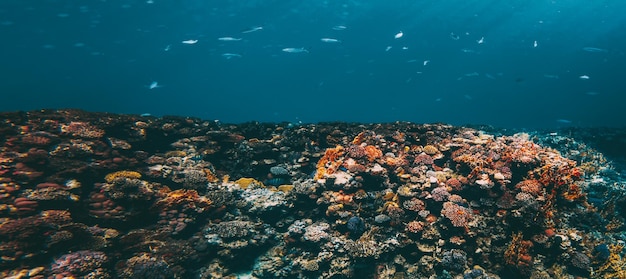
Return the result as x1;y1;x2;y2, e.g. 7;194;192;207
0;110;626;279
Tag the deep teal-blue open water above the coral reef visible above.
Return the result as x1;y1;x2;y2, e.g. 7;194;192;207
0;0;626;128
